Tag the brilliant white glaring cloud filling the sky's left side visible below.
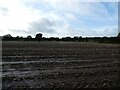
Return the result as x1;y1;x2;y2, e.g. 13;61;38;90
0;0;41;36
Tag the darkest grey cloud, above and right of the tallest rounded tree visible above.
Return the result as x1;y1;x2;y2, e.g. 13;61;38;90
29;18;55;33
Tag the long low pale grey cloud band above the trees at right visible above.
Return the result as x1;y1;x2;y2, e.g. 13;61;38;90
70;28;118;37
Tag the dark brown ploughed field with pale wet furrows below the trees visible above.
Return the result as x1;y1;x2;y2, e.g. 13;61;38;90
2;41;120;89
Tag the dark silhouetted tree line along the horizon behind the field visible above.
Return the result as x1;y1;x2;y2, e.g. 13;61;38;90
2;33;120;43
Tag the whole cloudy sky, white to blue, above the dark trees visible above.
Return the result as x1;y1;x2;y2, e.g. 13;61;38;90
0;0;118;37
